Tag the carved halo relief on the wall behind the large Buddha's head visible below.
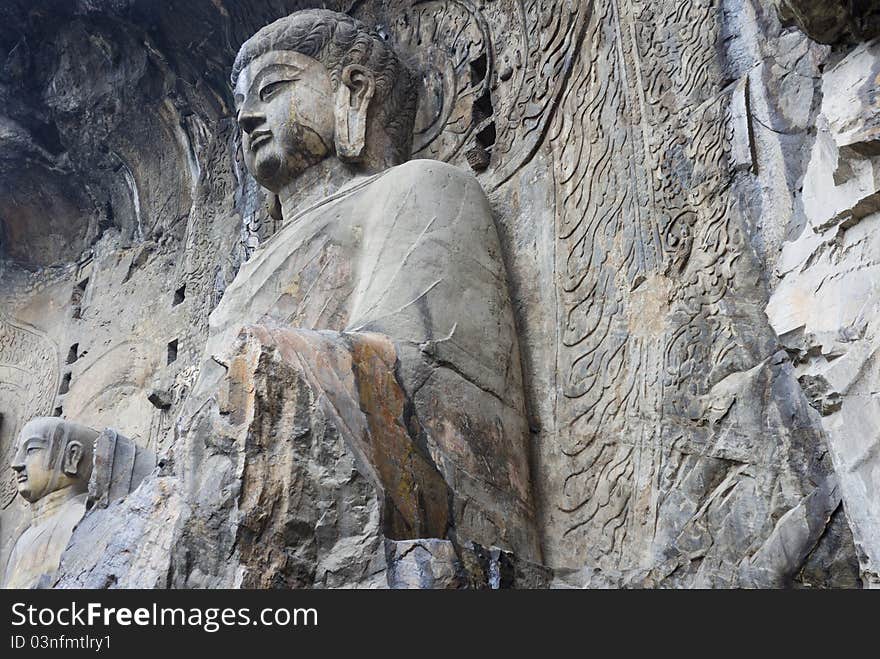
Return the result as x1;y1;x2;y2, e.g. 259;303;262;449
352;0;582;190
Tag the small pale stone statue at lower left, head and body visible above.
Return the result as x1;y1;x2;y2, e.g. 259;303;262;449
3;417;98;588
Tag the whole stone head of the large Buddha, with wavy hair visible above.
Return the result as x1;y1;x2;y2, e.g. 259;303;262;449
232;9;416;194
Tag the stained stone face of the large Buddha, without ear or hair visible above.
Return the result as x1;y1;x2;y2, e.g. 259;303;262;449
235;50;335;193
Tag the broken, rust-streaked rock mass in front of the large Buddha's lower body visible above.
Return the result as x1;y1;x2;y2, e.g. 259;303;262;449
58;327;528;588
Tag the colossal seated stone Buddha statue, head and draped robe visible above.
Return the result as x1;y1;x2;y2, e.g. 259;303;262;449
185;9;541;585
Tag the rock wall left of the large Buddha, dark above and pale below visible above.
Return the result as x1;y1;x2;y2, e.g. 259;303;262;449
0;0;340;576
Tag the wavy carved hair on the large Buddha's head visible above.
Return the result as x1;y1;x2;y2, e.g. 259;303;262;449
232;9;416;164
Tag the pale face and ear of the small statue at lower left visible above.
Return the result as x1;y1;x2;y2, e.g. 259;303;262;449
10;419;83;503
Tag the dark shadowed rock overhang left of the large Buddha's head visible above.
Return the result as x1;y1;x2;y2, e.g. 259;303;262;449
0;0;351;268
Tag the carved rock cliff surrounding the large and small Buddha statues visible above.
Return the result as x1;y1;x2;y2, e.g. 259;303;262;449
0;0;880;588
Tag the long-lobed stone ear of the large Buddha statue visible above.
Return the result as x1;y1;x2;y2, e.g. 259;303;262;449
335;64;376;162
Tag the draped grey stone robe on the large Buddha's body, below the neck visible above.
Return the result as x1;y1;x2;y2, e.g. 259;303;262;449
176;160;540;585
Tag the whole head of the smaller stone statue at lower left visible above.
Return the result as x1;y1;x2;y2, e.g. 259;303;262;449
10;417;98;503
